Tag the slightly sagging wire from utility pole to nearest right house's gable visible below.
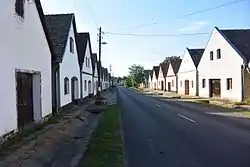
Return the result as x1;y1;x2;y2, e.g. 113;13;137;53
105;32;210;37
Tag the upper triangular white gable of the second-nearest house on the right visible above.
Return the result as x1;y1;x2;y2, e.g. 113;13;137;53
178;49;196;73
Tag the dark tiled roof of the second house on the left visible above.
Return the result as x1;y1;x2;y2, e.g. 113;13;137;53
45;14;76;62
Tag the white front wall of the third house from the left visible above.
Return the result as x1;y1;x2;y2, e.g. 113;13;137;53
82;41;93;97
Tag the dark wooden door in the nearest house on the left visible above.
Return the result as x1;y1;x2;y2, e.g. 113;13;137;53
16;72;34;128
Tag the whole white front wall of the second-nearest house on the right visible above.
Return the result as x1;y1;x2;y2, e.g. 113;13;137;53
178;49;199;96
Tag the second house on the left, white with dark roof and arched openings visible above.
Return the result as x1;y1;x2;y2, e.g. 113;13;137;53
45;14;80;108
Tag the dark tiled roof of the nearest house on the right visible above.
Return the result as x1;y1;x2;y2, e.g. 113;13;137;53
216;27;250;61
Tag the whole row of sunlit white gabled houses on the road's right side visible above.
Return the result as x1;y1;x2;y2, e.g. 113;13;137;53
145;27;250;101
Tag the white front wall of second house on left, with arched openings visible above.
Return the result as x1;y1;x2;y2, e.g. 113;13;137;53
60;21;80;107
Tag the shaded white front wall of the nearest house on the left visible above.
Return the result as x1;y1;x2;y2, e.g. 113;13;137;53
0;0;52;136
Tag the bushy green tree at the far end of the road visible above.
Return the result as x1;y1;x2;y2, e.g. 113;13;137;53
129;64;144;87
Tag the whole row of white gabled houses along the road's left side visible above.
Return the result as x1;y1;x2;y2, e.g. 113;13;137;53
0;0;111;136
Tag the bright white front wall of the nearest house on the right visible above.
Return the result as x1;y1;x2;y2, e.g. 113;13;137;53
198;29;243;101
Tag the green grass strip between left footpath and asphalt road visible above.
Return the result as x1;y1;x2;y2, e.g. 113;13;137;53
80;105;124;167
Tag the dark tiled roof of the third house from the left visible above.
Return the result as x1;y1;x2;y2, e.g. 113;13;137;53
76;32;93;69
